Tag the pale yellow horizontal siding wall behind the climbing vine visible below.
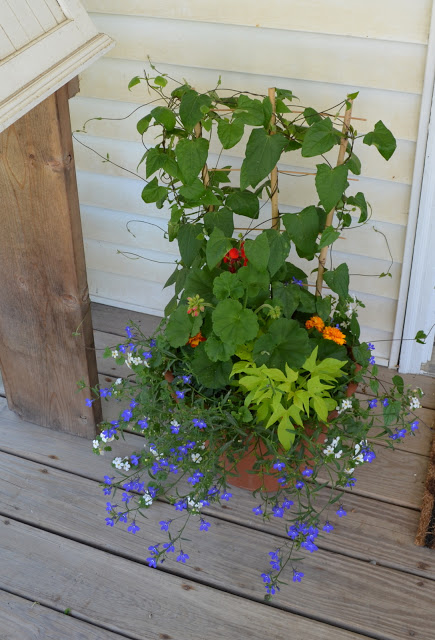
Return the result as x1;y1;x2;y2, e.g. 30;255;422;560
71;0;432;363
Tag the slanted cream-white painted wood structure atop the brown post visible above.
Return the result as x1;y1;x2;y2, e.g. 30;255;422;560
0;0;113;131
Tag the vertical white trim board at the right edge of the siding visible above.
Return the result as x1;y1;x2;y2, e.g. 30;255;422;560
389;0;435;373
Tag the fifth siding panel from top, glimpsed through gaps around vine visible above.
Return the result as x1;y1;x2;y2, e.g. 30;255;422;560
74;136;410;224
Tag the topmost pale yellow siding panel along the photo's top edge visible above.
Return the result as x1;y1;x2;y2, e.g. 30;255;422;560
84;0;432;43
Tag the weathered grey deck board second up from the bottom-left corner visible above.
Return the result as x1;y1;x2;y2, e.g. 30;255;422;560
0;519;374;640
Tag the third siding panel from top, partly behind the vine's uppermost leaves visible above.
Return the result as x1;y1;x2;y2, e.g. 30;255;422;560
77;58;420;141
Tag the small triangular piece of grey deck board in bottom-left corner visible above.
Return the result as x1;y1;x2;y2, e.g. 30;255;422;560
0;591;125;640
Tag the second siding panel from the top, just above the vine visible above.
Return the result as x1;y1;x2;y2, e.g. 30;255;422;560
92;13;426;93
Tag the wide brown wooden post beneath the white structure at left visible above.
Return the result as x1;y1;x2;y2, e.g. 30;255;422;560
0;86;101;437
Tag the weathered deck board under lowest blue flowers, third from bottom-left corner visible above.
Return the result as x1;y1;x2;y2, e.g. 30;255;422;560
0;455;435;640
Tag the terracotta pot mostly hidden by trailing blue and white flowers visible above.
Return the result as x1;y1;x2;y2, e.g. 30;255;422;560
221;365;361;492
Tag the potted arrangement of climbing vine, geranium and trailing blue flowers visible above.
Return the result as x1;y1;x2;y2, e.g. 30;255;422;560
82;67;421;598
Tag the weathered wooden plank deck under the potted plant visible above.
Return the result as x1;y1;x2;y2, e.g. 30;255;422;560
0;306;435;640
